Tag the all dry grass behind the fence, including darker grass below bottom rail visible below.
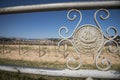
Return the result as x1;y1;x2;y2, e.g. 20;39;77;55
0;45;120;80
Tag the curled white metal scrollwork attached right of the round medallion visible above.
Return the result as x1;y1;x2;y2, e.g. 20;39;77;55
94;9;118;70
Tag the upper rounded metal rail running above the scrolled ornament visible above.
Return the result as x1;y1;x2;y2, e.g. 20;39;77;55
0;1;120;14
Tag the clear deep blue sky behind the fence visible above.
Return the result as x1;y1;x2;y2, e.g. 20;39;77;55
0;0;120;39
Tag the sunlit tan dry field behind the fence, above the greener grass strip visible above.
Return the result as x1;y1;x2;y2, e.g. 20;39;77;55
0;45;120;69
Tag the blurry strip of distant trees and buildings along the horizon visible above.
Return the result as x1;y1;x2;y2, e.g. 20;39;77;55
0;39;120;46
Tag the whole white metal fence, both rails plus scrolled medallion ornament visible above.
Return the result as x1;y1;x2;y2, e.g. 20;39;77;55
0;1;120;80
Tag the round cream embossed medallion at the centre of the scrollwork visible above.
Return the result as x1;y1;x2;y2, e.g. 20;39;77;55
73;25;104;53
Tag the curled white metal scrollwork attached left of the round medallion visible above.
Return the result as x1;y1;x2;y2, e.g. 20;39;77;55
58;9;82;69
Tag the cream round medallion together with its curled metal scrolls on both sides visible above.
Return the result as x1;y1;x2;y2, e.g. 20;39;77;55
58;9;118;70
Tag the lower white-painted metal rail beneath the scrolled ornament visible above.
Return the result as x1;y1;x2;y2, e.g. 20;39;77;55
0;65;120;79
